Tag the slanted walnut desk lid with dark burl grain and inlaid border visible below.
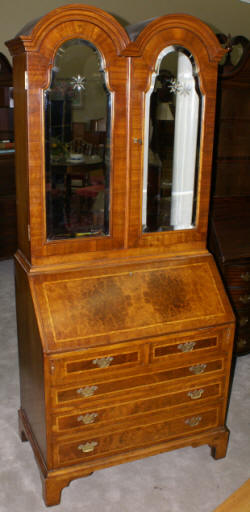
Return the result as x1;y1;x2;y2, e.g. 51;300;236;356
30;257;233;352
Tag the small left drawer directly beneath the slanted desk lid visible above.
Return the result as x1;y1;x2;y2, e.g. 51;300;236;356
50;346;143;385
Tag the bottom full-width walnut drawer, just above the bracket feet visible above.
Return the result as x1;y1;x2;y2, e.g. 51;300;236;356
54;408;219;467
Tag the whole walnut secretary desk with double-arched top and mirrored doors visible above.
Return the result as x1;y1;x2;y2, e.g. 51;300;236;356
7;4;234;505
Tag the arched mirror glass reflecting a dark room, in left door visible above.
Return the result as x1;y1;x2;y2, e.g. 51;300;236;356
44;39;112;240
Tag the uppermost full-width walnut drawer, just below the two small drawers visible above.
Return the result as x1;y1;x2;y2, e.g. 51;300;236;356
51;358;224;409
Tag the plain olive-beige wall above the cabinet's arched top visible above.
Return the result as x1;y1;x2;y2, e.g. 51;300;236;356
0;0;250;59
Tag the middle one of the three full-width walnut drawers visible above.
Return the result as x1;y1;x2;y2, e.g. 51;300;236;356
52;381;222;435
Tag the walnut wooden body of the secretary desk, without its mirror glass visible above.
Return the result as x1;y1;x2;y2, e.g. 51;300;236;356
8;4;234;505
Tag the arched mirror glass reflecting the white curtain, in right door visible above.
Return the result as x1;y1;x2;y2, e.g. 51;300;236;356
142;46;202;233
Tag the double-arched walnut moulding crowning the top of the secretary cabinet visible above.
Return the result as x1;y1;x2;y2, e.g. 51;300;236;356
6;4;225;62
